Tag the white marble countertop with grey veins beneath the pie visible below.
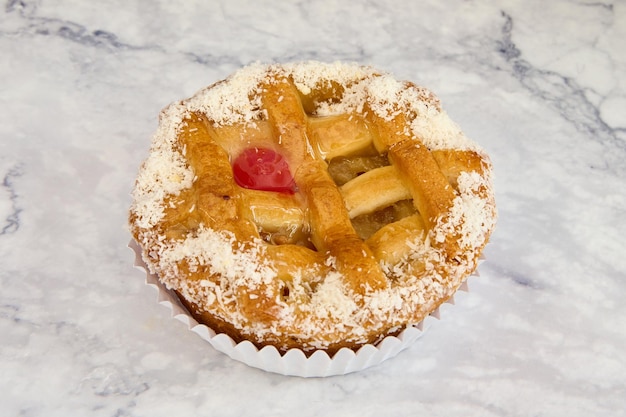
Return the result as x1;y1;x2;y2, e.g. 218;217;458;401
0;0;626;417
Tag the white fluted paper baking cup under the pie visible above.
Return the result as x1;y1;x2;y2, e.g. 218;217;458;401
128;240;478;377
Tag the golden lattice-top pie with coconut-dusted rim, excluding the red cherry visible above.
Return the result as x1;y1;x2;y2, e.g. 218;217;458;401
129;62;496;353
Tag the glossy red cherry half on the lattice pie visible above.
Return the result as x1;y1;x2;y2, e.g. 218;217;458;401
233;148;296;194
